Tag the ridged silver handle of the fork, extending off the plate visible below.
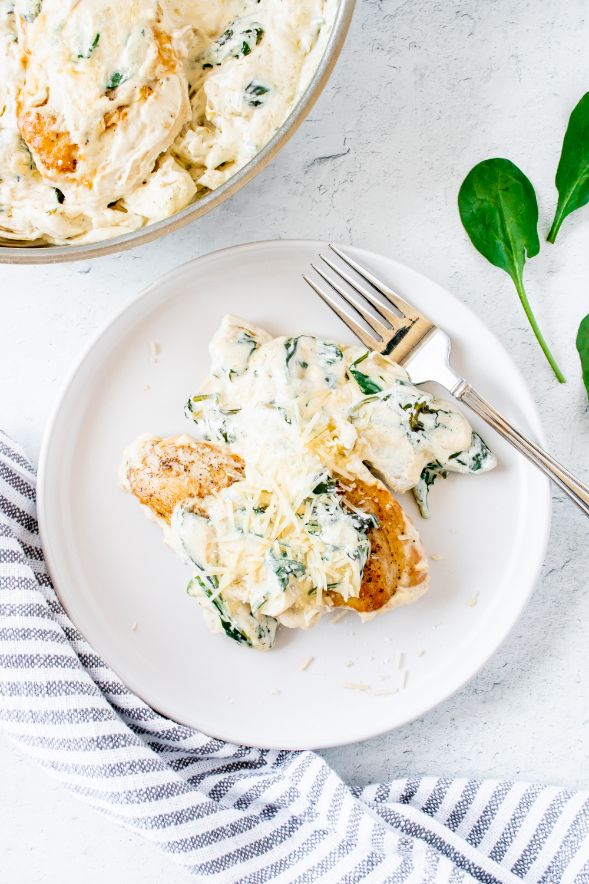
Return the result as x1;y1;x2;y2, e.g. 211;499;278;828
450;380;589;516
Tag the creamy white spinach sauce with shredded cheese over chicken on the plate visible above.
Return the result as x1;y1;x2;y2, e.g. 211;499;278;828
172;316;495;646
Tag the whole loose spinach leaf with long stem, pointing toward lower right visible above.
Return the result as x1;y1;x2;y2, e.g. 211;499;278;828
458;159;565;384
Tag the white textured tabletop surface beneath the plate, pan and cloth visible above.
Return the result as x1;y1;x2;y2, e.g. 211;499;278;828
0;0;589;884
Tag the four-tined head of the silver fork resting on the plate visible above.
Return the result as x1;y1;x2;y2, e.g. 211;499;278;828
303;244;433;362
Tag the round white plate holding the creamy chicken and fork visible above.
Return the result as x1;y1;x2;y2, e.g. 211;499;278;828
39;242;550;749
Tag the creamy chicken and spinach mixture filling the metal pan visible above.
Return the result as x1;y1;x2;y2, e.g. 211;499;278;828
0;0;337;243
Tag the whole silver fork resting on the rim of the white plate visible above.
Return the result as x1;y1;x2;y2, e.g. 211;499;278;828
303;245;589;515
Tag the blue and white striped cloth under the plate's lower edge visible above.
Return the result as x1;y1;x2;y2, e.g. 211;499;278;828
0;426;589;884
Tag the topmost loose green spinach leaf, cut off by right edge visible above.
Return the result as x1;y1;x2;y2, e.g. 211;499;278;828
548;92;589;242
